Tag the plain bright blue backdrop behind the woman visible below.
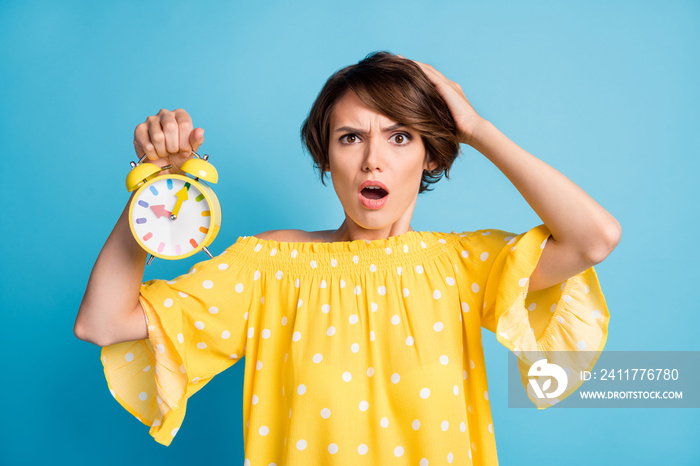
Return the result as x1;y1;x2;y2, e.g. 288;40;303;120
0;0;700;465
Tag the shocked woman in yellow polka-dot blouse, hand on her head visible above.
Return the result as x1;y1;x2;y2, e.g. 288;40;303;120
75;52;620;465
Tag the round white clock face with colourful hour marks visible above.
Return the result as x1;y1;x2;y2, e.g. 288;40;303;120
129;175;212;258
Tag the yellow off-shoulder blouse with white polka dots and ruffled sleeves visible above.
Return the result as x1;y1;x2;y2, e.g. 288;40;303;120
102;225;608;466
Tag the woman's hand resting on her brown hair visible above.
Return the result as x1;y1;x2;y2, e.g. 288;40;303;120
398;55;483;144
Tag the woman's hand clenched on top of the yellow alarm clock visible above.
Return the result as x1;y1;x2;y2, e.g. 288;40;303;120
134;108;204;173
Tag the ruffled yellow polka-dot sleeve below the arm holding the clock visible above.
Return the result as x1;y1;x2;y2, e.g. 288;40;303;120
102;245;261;445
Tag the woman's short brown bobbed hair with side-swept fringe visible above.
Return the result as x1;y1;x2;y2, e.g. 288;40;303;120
301;52;459;194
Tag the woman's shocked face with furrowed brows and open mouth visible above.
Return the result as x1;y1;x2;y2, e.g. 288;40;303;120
326;91;436;239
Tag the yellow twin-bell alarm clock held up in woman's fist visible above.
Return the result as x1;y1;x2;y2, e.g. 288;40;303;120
126;151;221;264
